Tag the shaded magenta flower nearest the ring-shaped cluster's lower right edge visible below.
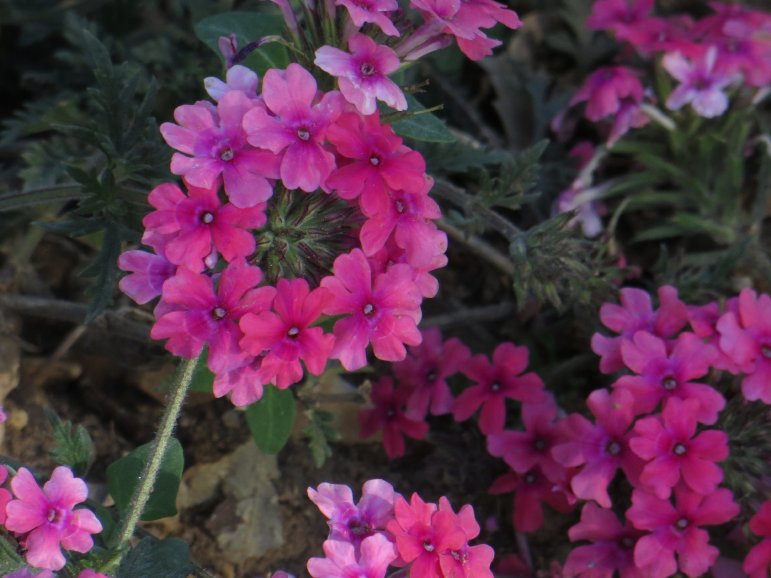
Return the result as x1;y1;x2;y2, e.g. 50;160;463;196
392;327;471;420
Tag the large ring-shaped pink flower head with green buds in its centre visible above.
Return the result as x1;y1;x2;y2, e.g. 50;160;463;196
119;60;446;405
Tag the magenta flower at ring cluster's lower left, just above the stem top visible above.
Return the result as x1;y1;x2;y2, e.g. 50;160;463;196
150;260;276;366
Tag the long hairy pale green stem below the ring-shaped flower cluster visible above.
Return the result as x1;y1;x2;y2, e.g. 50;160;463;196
116;356;200;550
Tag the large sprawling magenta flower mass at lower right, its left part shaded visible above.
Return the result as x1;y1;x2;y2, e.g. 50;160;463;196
361;286;771;578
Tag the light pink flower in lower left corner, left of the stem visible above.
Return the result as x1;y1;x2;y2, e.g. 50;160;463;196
5;466;102;570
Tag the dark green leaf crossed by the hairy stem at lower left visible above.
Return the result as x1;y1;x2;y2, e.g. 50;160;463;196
107;438;185;520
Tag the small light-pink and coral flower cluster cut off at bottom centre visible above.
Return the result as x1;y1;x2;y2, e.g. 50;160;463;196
308;480;493;578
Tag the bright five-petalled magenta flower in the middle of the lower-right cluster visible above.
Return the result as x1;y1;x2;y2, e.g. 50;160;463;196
629;397;728;499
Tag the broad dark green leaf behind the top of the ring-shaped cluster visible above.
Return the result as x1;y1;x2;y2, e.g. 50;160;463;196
195;12;289;76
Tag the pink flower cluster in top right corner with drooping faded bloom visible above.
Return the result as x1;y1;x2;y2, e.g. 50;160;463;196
552;0;771;237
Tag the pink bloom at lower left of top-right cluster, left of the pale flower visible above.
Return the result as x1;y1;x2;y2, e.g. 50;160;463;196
570;66;643;122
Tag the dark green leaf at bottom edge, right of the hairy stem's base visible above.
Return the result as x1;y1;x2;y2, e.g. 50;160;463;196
115;536;193;578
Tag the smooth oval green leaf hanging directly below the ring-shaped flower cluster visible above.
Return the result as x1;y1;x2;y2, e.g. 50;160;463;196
245;385;295;454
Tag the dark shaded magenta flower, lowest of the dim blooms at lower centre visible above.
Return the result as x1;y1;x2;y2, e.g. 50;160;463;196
487;467;576;532
